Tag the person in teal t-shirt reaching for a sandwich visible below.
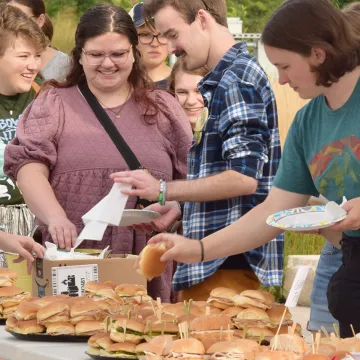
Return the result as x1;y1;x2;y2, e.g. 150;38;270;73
143;0;360;337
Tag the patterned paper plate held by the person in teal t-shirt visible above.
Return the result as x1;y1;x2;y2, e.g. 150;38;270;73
266;205;346;231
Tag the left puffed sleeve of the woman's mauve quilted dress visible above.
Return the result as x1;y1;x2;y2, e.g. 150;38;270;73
4;89;64;180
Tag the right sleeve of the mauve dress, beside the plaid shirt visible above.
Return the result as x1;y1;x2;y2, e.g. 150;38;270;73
156;90;193;180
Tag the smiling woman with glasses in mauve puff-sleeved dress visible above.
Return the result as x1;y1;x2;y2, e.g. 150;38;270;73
4;5;192;302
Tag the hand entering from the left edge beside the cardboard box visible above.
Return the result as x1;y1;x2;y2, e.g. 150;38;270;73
0;232;45;274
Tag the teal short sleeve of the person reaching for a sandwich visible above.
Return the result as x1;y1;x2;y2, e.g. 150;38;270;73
273;115;319;196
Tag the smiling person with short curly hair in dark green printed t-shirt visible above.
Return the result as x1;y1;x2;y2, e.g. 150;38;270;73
0;3;46;235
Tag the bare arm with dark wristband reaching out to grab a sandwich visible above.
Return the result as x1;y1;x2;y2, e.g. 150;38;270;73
149;187;310;263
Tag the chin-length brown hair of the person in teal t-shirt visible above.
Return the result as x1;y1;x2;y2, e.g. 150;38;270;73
262;0;360;87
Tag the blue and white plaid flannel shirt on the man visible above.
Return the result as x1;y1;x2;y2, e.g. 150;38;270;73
173;42;284;290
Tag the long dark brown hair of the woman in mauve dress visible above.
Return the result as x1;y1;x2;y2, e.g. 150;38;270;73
44;4;159;119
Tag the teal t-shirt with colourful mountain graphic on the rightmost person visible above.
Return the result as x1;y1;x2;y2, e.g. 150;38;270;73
273;80;360;236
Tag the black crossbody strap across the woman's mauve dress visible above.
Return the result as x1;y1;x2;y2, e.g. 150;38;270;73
78;81;152;208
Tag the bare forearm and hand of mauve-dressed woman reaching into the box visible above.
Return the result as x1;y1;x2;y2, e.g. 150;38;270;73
17;163;77;250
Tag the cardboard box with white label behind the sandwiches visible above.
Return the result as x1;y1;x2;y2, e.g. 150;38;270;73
32;255;147;297
